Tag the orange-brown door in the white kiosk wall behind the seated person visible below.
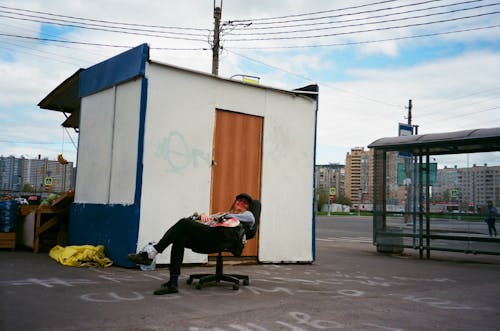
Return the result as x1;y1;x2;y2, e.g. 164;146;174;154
210;109;264;256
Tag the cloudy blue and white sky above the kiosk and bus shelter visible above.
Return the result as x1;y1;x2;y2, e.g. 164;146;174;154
0;0;500;167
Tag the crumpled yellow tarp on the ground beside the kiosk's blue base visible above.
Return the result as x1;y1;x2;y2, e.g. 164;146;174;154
49;245;113;267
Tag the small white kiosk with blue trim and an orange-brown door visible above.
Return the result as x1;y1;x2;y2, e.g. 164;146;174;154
39;44;318;266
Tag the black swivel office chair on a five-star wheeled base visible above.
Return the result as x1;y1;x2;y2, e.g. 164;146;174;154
187;200;261;290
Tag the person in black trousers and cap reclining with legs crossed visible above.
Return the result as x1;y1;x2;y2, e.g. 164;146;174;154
128;193;255;295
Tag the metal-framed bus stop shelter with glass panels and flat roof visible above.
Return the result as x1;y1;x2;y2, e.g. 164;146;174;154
368;127;500;258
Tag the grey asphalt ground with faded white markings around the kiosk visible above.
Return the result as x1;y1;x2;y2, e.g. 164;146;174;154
0;217;500;331
